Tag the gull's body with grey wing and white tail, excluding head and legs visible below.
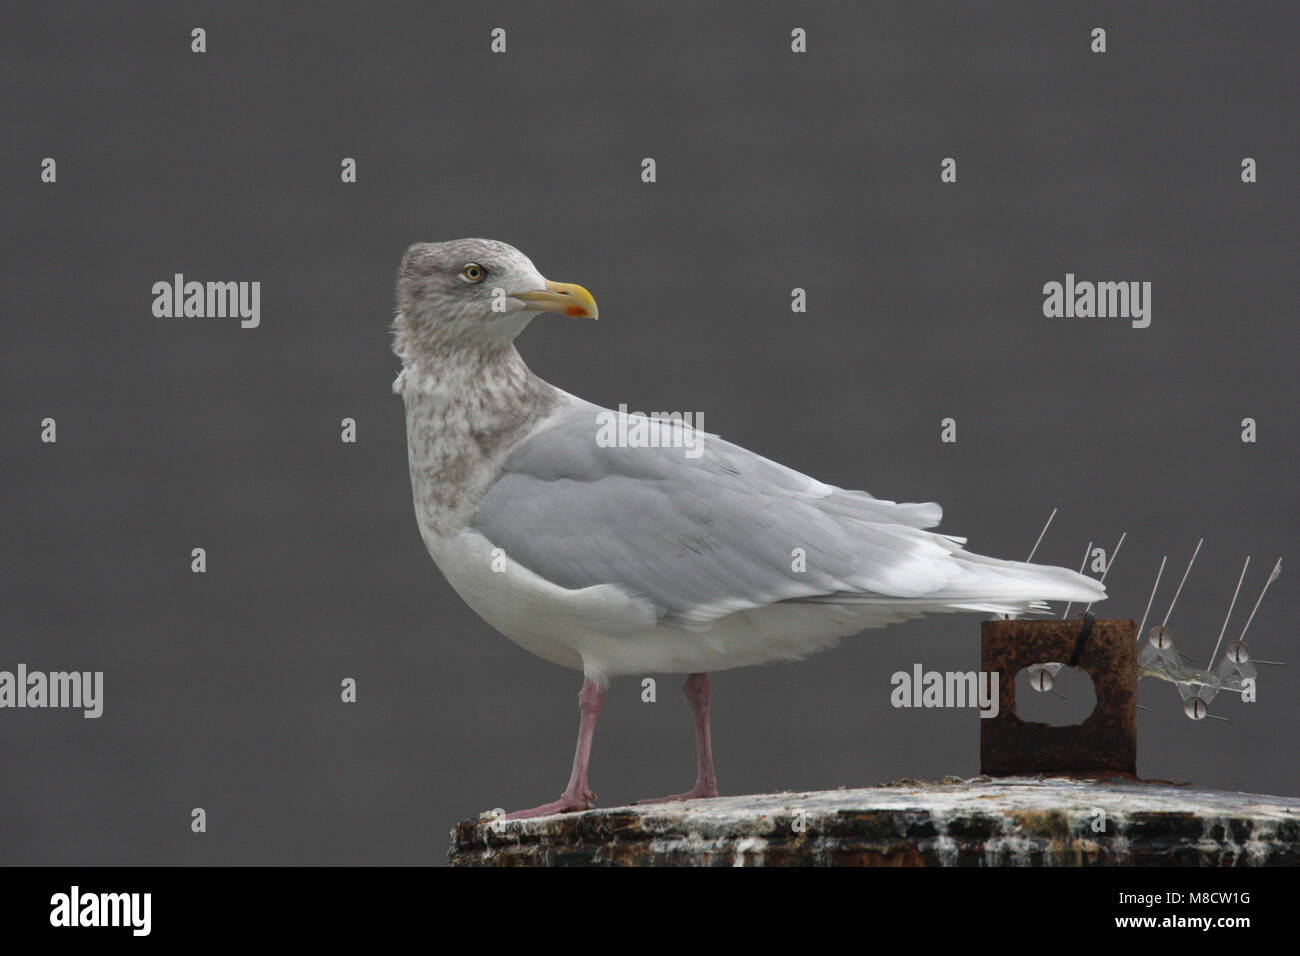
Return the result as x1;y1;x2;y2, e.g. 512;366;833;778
400;374;1104;680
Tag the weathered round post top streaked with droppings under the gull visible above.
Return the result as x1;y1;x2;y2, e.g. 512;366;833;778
450;778;1300;866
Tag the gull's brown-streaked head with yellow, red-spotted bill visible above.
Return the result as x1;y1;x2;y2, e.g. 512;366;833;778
397;239;597;349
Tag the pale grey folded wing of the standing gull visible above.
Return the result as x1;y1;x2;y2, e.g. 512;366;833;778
472;401;962;627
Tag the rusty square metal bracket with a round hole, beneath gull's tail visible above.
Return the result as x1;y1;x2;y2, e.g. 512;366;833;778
979;615;1138;777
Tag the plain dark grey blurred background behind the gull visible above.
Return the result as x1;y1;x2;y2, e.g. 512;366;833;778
0;3;1300;864
